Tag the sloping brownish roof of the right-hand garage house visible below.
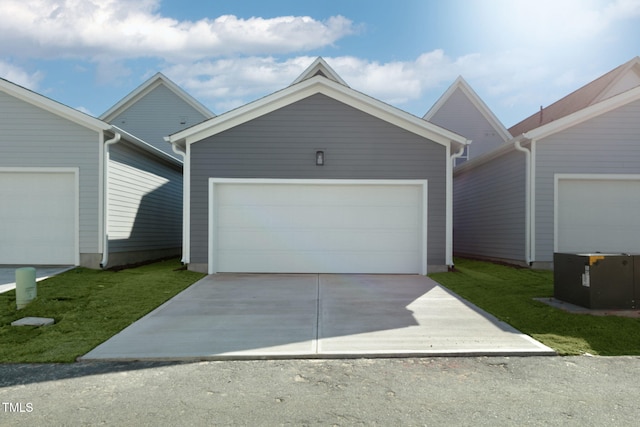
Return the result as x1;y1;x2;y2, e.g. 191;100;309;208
509;56;640;136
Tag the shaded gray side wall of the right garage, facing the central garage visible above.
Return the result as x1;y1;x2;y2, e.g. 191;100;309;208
453;150;526;262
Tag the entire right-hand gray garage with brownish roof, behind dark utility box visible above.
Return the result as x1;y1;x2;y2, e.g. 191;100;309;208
453;58;640;268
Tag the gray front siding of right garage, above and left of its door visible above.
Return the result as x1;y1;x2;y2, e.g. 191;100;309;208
535;101;640;262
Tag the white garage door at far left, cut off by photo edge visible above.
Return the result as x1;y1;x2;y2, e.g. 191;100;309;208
0;171;77;265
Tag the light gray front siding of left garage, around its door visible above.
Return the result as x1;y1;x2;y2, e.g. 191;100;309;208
0;91;101;253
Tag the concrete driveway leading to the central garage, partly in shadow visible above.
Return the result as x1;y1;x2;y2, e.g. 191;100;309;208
81;274;555;360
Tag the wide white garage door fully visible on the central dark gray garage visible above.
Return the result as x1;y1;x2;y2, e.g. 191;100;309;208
210;181;426;274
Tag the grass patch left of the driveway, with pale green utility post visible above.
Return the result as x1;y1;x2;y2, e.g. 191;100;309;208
0;260;204;363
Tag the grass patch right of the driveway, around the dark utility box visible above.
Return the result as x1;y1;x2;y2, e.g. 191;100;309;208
430;259;640;356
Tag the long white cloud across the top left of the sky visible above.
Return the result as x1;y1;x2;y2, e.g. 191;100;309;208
0;0;355;62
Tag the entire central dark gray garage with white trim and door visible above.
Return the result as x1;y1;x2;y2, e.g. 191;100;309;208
167;58;468;274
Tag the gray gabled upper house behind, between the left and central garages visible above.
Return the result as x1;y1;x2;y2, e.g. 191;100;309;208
100;73;215;158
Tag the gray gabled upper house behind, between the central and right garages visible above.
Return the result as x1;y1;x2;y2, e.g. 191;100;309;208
423;76;511;166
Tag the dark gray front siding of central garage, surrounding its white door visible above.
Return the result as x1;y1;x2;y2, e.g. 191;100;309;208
190;94;446;265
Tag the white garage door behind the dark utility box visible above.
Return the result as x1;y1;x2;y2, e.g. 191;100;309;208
556;179;640;253
